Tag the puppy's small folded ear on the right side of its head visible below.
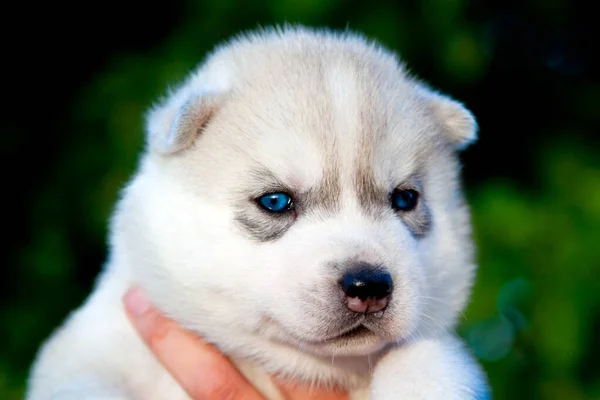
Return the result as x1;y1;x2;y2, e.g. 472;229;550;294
425;90;478;150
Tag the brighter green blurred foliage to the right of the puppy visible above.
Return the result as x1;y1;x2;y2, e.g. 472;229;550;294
462;141;600;400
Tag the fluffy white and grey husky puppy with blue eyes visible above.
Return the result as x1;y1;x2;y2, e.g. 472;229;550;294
27;27;487;400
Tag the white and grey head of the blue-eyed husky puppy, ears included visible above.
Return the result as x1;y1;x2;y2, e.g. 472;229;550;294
114;29;476;355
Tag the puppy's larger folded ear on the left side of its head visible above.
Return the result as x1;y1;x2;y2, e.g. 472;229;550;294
146;93;219;154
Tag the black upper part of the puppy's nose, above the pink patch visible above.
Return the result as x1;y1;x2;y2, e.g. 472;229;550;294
340;265;392;301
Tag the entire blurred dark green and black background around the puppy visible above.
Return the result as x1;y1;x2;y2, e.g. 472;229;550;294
0;0;600;400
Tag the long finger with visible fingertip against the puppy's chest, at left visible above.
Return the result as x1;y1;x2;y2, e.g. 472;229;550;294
124;289;264;400
